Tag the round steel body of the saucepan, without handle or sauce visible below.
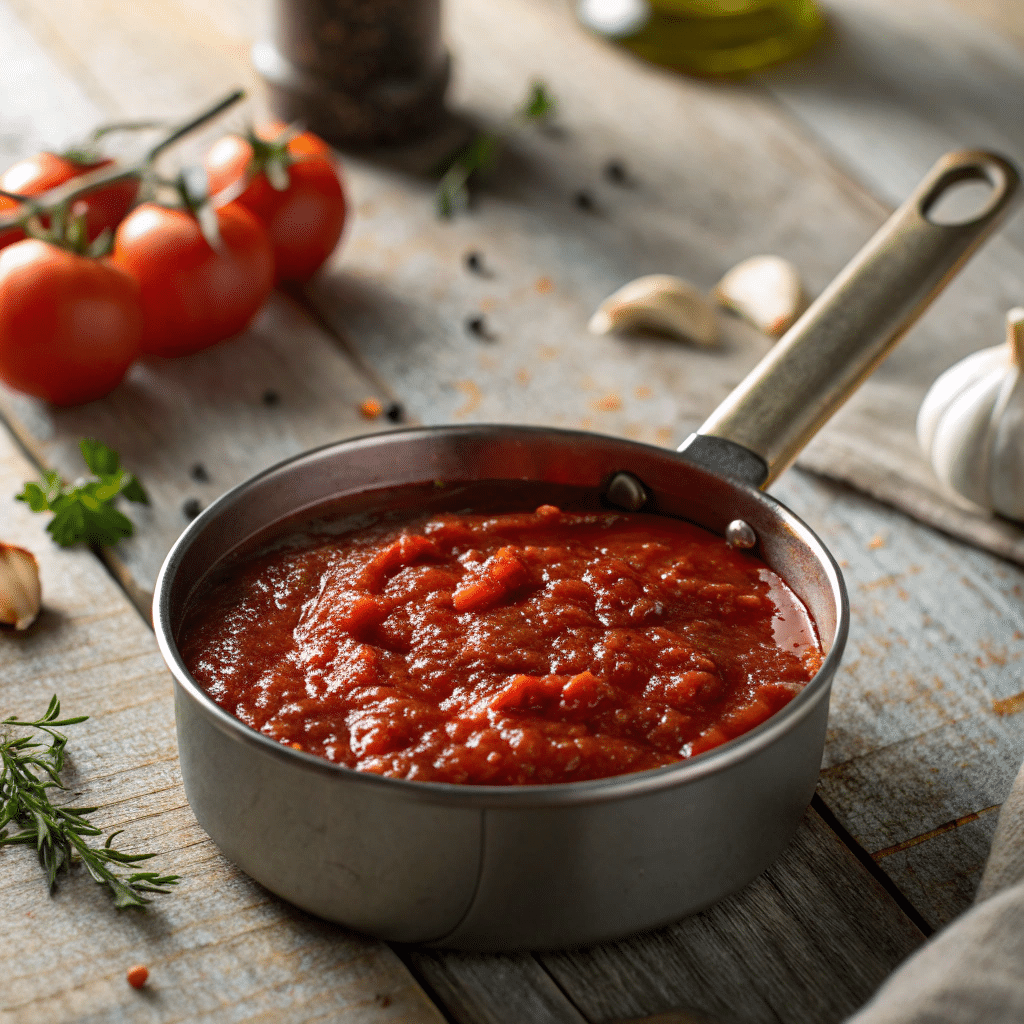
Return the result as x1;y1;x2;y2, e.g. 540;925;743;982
156;427;847;948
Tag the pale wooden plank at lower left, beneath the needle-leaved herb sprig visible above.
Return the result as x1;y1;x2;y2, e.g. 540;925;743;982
0;419;442;1024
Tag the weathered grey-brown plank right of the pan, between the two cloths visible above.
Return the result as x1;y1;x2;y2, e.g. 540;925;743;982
773;472;1024;927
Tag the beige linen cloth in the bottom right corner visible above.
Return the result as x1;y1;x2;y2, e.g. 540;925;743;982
847;769;1024;1024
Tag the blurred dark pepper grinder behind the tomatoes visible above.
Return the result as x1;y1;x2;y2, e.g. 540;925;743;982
253;0;450;150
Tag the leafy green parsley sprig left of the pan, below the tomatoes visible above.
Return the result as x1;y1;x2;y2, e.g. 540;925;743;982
16;437;150;548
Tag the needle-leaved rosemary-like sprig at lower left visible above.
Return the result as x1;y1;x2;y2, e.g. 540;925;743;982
0;696;179;908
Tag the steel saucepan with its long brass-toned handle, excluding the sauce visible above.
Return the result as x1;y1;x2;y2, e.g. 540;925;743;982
154;152;1019;949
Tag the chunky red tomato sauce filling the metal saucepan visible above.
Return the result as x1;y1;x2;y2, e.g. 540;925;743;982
179;505;822;785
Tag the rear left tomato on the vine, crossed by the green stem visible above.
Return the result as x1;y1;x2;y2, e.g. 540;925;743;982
0;153;138;249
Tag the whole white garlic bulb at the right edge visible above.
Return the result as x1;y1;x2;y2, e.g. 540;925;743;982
918;307;1024;519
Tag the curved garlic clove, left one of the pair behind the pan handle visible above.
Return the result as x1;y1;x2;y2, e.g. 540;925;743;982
588;273;718;346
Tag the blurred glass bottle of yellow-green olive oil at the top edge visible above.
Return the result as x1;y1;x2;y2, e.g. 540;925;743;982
578;0;824;77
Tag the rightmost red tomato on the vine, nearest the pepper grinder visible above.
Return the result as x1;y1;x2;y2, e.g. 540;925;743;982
206;124;346;281
